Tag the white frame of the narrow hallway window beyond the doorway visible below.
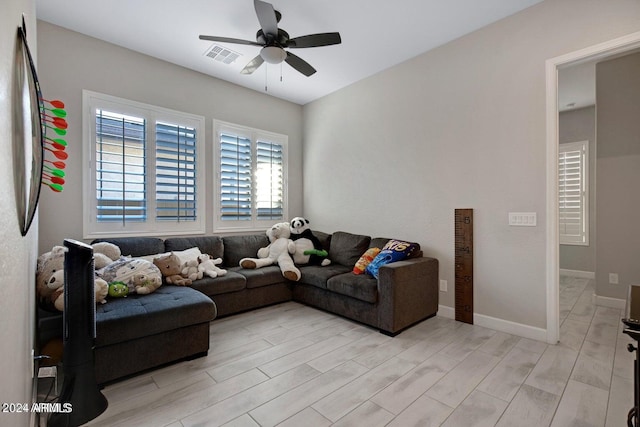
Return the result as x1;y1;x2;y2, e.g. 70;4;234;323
558;141;589;246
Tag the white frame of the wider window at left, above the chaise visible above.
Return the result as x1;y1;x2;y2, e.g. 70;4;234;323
82;90;207;239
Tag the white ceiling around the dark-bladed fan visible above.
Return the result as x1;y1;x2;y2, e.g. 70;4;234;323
36;0;542;105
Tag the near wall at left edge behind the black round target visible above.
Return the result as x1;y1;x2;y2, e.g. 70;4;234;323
0;0;38;426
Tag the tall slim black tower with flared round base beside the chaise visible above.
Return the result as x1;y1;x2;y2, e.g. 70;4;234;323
47;239;108;427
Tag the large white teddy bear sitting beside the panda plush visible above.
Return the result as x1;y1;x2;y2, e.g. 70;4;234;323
240;222;300;281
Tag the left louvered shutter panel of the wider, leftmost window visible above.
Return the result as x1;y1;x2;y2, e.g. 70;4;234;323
96;110;147;223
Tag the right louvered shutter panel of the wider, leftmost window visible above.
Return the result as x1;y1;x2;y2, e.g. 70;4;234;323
156;122;197;221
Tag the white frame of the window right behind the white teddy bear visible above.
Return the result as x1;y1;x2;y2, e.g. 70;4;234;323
212;119;289;233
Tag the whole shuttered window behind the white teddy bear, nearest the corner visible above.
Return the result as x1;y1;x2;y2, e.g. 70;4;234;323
214;121;287;231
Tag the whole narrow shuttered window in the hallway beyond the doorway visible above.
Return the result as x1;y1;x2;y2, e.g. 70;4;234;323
558;141;589;245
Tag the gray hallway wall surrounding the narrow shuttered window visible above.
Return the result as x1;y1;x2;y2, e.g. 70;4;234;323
558;108;596;272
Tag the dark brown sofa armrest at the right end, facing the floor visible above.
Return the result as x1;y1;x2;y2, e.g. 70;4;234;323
378;257;439;335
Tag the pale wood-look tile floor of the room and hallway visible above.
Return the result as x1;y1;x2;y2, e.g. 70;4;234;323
81;276;635;427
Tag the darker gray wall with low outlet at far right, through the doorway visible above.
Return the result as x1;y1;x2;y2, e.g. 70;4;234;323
596;53;640;298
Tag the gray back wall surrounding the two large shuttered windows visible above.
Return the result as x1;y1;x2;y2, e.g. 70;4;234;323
38;21;302;252
